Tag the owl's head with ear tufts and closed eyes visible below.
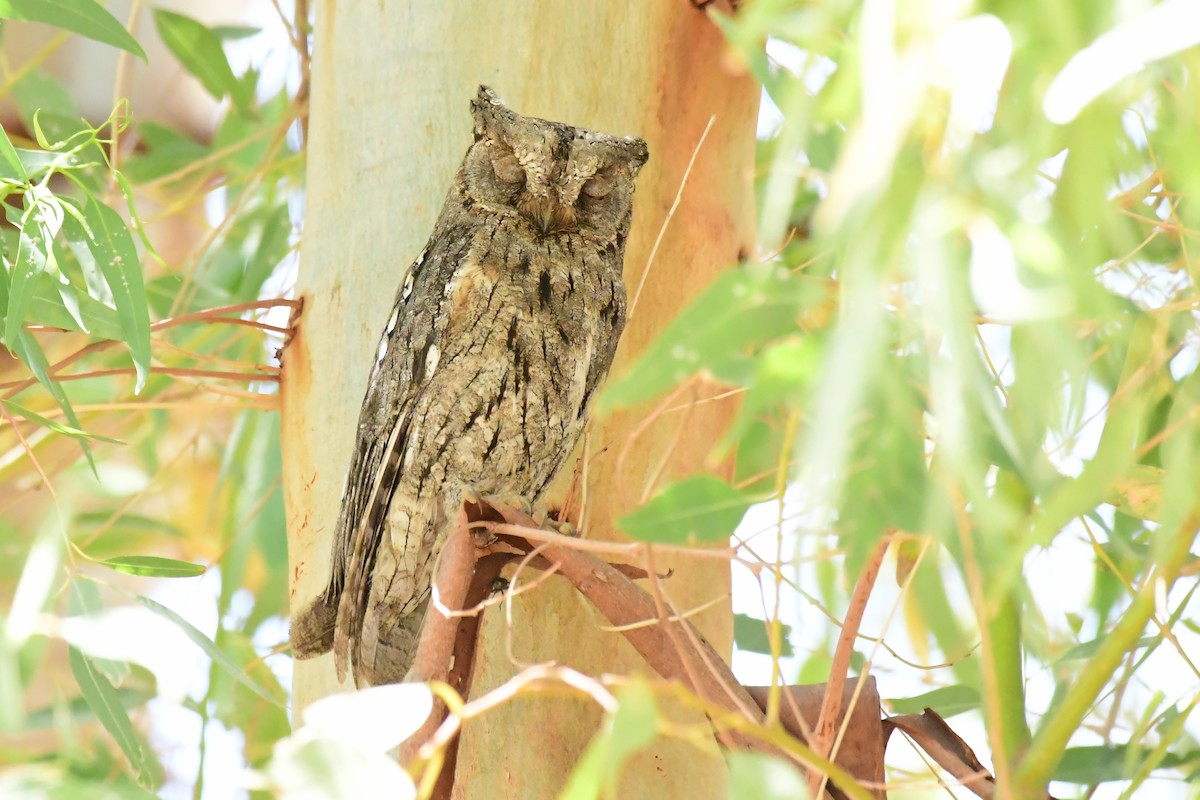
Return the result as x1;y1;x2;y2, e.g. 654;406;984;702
462;86;649;240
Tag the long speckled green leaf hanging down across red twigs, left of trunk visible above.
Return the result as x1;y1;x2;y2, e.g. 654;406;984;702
77;197;150;393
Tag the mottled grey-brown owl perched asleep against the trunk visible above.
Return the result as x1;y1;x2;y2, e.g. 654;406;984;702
292;86;648;685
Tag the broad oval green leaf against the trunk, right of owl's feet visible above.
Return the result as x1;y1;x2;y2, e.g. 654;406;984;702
618;475;750;545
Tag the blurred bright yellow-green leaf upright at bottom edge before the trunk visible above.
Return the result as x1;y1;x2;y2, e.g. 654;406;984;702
558;681;659;800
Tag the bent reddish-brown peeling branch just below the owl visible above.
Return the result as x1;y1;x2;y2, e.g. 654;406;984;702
402;500;1012;796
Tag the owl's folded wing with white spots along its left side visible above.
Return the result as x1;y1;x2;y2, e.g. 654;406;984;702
319;233;462;679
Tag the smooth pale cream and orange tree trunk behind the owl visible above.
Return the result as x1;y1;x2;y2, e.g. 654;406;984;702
283;0;758;800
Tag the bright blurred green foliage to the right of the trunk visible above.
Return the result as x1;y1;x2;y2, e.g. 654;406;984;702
619;0;1200;798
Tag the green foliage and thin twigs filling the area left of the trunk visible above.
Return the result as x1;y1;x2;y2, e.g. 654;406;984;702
0;0;304;798
